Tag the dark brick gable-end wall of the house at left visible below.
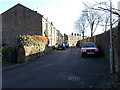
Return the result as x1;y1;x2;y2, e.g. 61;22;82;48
2;4;42;47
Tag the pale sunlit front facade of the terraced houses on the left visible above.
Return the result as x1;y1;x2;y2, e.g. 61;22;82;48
42;17;63;46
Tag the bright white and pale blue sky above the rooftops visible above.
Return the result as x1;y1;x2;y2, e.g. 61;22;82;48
0;0;119;36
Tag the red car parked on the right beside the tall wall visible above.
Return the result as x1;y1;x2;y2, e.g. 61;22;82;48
81;42;99;57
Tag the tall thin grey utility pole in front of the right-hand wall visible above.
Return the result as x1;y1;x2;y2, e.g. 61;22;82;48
109;0;113;74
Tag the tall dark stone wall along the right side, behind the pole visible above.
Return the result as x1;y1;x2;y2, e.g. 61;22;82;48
80;23;120;72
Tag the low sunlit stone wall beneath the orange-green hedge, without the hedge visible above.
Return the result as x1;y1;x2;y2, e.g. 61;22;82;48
16;45;53;63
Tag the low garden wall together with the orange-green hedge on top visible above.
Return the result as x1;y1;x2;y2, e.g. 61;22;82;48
17;35;48;63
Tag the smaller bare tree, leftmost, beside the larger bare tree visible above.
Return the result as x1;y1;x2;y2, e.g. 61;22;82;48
74;13;88;39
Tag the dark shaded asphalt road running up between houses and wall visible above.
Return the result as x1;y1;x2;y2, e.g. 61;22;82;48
2;48;110;88
